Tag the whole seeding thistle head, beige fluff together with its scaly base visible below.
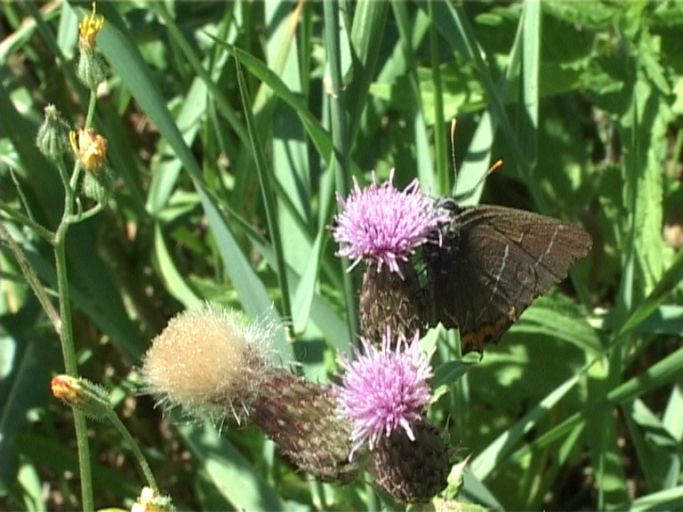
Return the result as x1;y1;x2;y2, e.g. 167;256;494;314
142;306;361;481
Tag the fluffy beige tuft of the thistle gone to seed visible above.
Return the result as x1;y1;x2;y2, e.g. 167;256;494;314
142;305;277;422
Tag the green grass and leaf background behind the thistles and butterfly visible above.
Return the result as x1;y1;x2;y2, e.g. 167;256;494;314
0;0;683;510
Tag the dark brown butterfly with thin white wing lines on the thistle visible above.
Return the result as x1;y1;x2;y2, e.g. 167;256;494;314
424;198;593;351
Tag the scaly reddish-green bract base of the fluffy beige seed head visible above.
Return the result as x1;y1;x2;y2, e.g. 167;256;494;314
250;370;362;482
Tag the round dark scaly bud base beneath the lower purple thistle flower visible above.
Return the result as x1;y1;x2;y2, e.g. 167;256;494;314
372;421;451;503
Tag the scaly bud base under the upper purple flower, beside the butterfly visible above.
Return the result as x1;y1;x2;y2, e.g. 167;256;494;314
359;262;424;345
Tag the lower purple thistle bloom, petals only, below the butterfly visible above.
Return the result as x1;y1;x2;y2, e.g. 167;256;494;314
334;329;432;457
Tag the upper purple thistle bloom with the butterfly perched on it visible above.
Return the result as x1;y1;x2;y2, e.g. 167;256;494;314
332;170;448;277
